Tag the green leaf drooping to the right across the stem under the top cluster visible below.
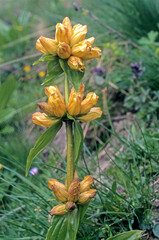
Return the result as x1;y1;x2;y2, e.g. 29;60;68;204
59;59;84;92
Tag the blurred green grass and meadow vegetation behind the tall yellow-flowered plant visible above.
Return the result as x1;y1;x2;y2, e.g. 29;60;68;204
0;0;159;240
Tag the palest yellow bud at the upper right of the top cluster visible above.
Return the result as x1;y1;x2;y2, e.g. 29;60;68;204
70;24;87;47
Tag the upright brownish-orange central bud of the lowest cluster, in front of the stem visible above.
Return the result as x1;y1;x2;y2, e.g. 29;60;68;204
68;178;80;202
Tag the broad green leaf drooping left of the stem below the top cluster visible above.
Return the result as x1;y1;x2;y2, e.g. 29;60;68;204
42;58;63;85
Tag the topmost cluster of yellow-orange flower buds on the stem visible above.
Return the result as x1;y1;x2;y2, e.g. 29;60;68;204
36;17;101;71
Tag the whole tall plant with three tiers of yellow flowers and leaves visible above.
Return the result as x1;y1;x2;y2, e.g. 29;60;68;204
26;17;102;240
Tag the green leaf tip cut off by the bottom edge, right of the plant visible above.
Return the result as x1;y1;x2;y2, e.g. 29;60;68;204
107;230;144;240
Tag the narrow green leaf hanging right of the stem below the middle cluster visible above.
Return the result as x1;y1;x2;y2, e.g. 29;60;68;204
74;120;83;169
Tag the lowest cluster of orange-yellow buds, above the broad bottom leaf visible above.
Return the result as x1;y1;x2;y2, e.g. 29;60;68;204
48;175;97;215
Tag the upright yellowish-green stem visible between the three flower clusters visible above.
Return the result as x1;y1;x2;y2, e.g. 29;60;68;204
65;74;74;189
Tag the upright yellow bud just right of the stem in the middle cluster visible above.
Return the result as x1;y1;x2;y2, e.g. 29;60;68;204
67;88;82;116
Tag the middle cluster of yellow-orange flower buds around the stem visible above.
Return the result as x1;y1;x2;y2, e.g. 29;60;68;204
32;84;102;127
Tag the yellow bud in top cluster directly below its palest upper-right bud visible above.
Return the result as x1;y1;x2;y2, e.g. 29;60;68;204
72;37;95;57
